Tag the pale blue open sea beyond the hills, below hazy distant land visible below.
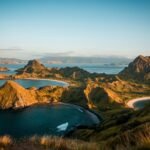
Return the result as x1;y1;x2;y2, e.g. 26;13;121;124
0;64;125;74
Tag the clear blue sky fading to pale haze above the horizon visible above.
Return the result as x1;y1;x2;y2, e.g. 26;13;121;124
0;0;150;59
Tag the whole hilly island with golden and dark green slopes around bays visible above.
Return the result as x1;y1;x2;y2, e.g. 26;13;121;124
0;55;150;150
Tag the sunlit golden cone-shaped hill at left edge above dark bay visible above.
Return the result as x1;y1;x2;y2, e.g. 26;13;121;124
0;81;37;109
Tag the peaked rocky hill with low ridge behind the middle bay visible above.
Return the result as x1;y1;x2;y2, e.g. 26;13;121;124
15;60;91;80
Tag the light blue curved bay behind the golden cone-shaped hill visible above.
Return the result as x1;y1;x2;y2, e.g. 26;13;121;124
0;80;68;88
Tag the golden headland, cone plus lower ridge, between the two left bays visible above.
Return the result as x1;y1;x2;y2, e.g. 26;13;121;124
0;80;66;109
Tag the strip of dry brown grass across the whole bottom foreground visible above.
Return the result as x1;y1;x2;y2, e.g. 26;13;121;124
0;131;150;150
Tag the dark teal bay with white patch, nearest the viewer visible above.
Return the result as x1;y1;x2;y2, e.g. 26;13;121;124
0;104;100;137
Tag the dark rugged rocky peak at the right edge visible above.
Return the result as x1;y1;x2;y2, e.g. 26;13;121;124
119;55;150;83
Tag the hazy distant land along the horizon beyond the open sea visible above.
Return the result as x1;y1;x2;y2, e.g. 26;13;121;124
0;56;132;65
